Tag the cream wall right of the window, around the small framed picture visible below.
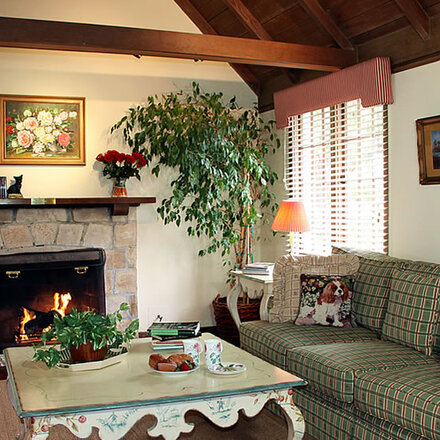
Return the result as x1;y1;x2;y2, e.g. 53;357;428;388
389;62;440;263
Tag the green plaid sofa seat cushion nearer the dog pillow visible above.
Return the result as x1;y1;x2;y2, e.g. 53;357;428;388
286;340;436;403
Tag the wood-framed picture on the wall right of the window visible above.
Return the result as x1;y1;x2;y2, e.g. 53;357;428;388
416;116;440;185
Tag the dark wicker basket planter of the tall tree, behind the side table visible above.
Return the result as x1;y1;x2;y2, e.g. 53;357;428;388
212;294;261;346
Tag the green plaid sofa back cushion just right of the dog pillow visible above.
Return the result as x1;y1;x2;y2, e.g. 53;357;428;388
332;247;398;334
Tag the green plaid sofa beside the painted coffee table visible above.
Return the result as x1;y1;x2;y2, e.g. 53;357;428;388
240;248;440;440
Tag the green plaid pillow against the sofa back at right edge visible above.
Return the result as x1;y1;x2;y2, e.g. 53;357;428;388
382;270;440;355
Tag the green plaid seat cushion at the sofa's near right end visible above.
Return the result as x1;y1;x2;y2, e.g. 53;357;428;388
354;363;440;440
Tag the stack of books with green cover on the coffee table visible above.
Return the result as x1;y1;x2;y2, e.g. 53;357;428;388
148;321;201;350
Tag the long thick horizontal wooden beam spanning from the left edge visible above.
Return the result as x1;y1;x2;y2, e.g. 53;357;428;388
0;17;356;72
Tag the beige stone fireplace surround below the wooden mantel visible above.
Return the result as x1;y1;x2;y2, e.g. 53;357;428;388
0;207;138;344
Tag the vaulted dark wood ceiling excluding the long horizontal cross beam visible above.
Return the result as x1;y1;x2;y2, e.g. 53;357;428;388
175;0;440;110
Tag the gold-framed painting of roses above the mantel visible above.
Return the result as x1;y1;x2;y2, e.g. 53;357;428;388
0;95;86;165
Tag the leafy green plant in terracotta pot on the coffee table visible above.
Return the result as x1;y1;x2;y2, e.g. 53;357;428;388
33;303;139;368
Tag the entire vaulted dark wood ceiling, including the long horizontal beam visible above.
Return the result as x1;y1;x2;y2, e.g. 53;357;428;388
0;0;440;111
